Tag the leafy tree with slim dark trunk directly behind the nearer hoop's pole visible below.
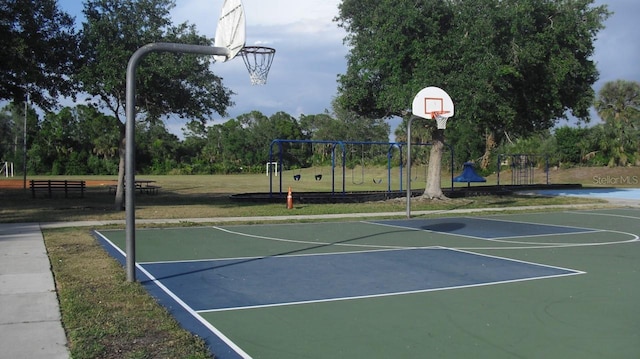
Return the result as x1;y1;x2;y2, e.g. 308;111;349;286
75;0;232;209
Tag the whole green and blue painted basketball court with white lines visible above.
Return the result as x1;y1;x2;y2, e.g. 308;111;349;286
97;209;640;359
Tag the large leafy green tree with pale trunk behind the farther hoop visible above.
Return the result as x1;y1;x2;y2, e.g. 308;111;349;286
336;0;608;198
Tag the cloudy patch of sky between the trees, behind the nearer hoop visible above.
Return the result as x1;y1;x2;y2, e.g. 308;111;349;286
166;0;347;129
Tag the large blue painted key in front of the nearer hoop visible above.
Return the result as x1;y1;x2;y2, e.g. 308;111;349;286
143;248;579;311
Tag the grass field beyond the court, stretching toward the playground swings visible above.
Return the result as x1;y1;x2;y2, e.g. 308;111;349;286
0;174;608;222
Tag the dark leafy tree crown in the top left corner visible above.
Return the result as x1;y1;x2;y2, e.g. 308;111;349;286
0;0;78;110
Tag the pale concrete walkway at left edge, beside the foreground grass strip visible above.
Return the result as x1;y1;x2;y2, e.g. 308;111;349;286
0;223;69;359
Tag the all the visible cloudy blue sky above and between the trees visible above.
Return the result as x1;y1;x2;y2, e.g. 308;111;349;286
58;0;640;135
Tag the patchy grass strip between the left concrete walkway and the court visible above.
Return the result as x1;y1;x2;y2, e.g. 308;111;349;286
43;229;212;359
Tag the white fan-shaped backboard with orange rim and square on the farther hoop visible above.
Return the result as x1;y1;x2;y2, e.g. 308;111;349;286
411;86;454;128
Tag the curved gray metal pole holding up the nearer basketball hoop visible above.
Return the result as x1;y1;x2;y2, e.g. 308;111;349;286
125;42;230;282
